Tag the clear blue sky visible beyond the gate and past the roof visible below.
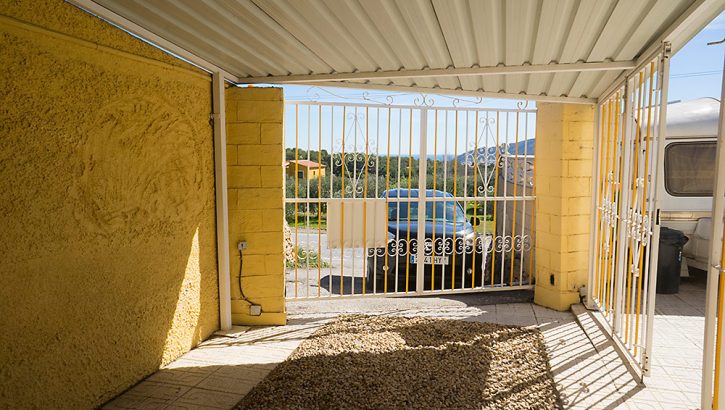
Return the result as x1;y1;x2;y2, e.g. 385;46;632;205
283;12;725;156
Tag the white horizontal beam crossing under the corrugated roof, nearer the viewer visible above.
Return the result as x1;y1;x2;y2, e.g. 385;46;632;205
239;61;635;84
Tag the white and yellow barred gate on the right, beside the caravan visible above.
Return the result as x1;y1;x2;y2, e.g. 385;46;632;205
587;45;669;376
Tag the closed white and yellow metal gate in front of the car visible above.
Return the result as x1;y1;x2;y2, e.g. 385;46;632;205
285;96;535;299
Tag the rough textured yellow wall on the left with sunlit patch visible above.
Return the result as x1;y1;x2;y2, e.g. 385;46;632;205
0;0;219;409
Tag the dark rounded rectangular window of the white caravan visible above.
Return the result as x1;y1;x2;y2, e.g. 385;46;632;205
665;141;716;196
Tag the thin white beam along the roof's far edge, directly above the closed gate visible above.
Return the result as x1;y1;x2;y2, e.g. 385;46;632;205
298;81;597;104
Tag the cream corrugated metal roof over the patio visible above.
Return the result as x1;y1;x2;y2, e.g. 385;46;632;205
86;0;723;102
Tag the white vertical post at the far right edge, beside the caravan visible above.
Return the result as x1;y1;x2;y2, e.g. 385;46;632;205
700;54;725;409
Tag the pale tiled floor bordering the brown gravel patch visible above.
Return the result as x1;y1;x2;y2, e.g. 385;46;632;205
105;286;704;409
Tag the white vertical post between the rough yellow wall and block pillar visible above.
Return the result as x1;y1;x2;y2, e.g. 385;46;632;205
212;72;232;330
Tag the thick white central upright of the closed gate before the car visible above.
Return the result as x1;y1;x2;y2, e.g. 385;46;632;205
411;107;428;294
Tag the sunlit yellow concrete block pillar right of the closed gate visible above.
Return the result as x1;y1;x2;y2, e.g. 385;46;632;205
534;103;595;310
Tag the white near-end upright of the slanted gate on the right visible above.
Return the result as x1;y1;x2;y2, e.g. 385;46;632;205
642;43;671;376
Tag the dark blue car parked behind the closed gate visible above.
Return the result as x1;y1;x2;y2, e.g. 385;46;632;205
367;189;490;293
